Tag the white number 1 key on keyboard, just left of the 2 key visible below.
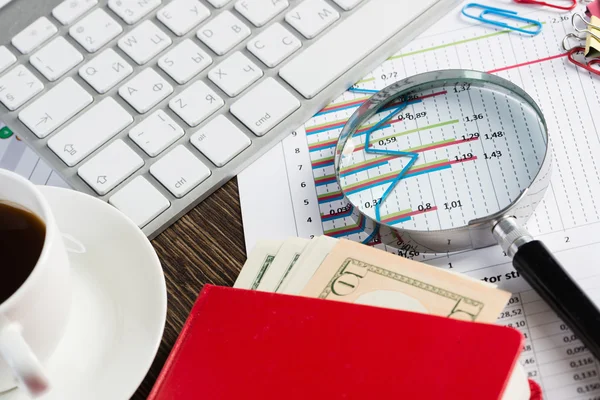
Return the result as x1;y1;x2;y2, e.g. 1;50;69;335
29;36;83;82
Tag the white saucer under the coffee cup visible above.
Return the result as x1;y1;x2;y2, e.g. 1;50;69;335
0;187;167;400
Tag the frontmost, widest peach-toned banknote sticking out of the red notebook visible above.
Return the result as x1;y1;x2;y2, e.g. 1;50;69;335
300;240;510;323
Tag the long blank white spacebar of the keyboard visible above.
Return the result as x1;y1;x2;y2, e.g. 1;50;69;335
279;0;438;99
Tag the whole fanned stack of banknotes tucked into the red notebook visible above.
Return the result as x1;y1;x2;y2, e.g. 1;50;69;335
234;236;530;400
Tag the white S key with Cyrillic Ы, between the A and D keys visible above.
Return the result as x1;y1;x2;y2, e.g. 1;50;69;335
158;39;212;85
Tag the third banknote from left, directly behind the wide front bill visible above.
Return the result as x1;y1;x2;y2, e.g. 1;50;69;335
277;236;338;294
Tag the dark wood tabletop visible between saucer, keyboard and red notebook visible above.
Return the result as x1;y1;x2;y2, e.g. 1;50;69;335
132;179;246;400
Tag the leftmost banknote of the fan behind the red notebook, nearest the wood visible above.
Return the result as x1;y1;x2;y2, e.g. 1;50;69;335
233;240;283;290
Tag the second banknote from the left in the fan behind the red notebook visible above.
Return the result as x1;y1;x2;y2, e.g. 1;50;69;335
256;238;310;292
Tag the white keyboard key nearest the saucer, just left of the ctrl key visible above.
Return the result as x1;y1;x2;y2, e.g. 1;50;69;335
108;176;171;228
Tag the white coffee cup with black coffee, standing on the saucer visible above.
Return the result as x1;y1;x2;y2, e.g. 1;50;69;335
0;169;71;397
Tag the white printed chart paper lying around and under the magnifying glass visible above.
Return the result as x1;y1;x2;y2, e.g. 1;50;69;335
238;1;600;400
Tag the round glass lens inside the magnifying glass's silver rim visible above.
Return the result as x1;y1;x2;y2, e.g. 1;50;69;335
336;81;547;231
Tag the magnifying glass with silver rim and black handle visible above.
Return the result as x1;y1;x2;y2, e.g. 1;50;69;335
335;70;600;359
